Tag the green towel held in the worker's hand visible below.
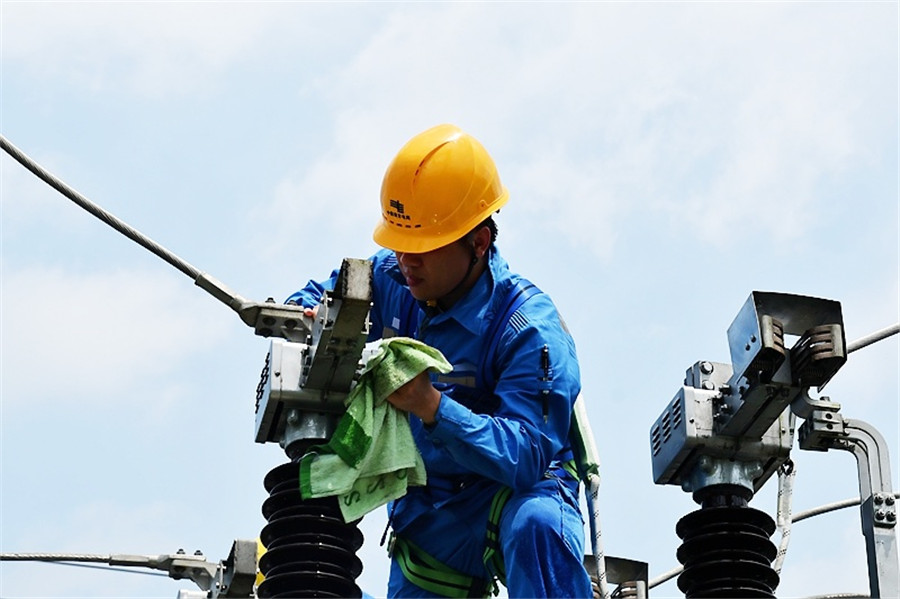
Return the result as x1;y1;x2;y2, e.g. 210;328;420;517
300;337;452;522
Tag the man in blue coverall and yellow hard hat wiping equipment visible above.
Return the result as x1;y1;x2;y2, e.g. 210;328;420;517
289;124;592;598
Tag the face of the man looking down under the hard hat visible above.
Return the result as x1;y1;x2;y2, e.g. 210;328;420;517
396;242;472;303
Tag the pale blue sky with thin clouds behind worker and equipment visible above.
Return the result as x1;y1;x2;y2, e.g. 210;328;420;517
0;0;900;598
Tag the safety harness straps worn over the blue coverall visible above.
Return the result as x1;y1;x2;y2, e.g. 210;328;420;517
389;279;578;599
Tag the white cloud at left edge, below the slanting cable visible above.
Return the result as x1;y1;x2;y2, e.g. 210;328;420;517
0;266;231;405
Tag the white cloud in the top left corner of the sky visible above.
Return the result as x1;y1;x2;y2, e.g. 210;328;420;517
3;2;338;98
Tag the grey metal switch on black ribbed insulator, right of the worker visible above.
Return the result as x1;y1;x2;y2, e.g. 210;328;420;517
650;291;900;597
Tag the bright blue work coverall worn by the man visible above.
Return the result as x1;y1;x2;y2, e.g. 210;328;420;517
289;246;592;598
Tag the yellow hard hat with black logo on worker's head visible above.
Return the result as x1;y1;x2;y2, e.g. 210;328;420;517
372;125;509;254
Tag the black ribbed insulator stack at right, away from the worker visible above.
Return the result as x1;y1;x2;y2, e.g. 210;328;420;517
675;490;779;599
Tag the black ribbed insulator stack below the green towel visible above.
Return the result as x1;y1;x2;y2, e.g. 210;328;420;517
256;462;363;599
